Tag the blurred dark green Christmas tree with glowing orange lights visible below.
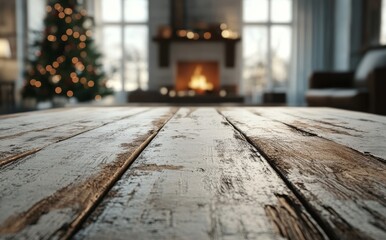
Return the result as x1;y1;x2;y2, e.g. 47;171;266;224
22;0;112;101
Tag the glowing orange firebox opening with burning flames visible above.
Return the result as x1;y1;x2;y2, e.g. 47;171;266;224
175;61;220;94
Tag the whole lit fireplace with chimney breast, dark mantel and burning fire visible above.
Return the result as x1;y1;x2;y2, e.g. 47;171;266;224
144;0;243;103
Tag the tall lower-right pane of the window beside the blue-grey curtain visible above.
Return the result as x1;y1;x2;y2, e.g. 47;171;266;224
271;26;291;88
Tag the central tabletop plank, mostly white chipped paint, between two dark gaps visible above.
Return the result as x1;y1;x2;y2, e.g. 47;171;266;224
74;108;326;239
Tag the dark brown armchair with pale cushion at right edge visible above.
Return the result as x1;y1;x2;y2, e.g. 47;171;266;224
306;47;386;115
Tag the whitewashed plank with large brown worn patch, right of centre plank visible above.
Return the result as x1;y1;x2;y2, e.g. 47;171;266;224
221;109;386;240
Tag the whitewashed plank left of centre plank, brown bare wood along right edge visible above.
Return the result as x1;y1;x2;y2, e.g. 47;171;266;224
0;108;173;239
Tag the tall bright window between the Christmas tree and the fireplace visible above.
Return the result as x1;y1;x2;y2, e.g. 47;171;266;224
97;0;149;91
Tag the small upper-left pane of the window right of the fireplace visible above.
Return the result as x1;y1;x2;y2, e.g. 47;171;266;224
243;0;268;22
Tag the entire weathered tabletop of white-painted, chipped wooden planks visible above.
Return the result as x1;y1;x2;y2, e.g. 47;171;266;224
0;107;386;239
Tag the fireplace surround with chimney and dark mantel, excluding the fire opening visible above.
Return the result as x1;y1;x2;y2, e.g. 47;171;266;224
148;0;242;100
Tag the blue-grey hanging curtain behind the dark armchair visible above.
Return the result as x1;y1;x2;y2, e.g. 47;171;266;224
288;0;334;106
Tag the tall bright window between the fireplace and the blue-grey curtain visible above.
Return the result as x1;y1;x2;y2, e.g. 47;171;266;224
242;0;292;94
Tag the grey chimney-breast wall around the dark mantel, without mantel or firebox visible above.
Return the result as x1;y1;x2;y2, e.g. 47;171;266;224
149;0;242;90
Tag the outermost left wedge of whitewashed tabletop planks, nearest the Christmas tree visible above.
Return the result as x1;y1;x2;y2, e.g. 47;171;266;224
0;108;148;166
